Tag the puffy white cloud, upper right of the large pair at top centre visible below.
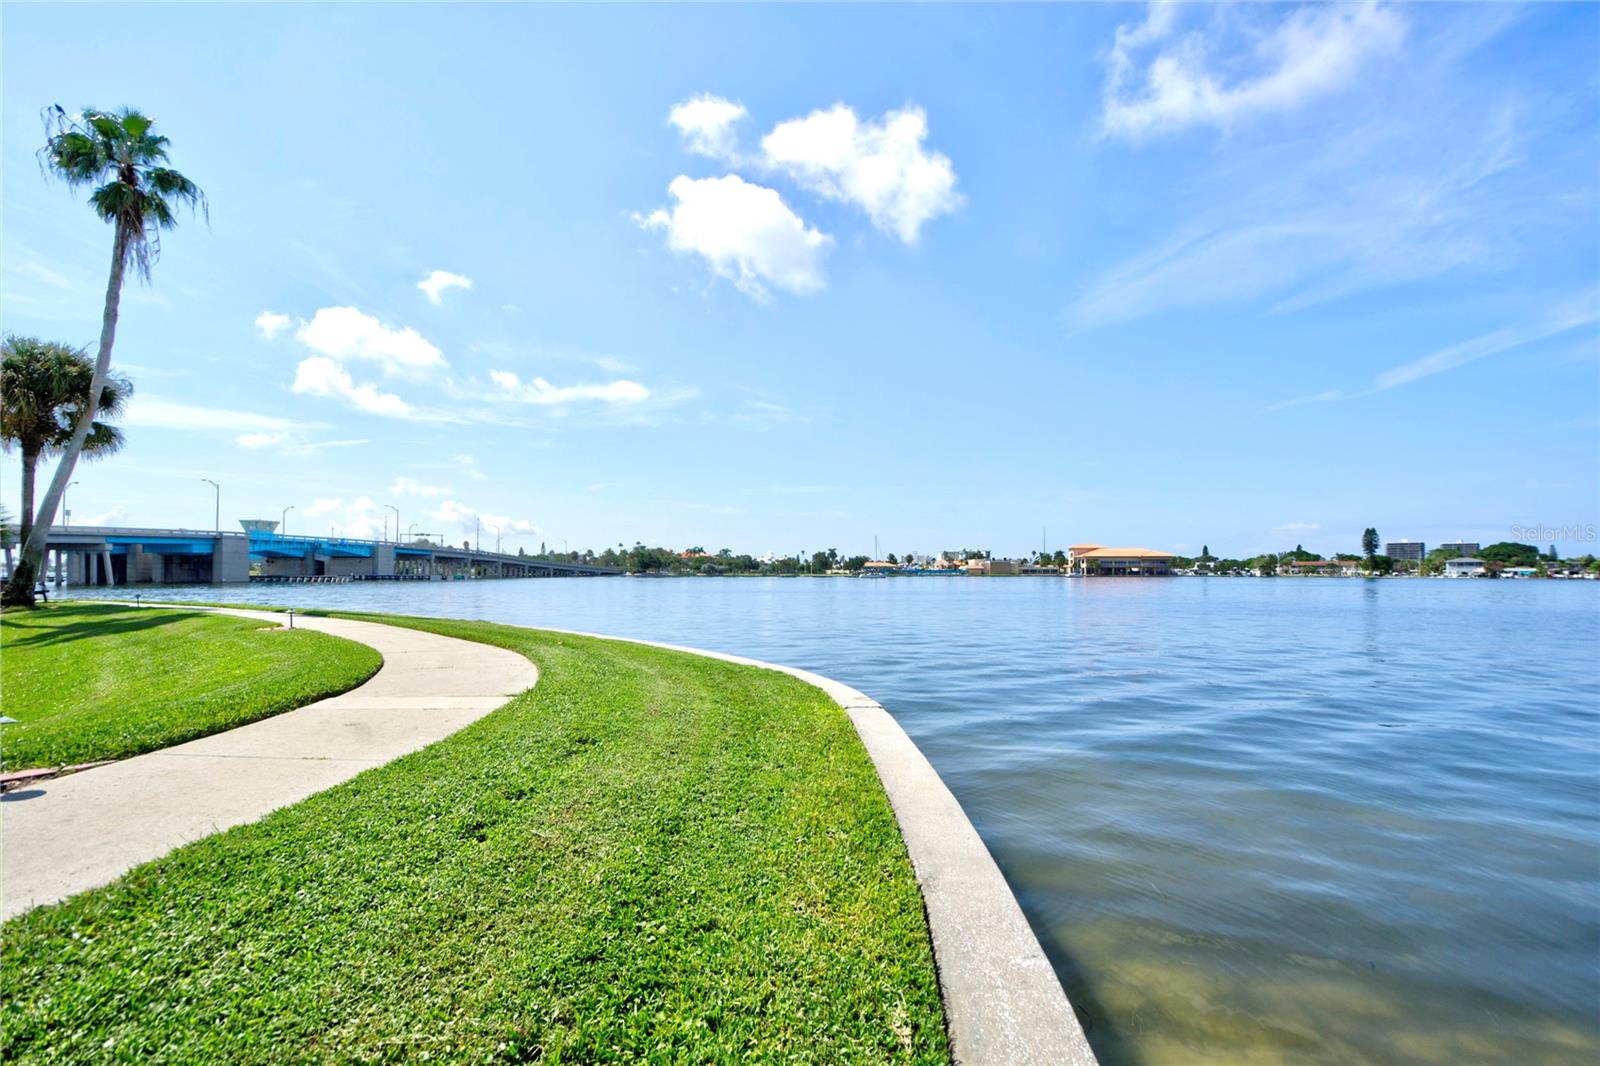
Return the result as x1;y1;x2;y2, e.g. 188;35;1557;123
762;104;962;245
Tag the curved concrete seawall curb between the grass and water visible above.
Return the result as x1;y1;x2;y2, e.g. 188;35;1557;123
539;626;1096;1066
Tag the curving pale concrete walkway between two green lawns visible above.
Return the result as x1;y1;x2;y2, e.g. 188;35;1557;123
0;607;539;919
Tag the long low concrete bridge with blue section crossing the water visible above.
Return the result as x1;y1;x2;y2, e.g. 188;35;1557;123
6;525;622;586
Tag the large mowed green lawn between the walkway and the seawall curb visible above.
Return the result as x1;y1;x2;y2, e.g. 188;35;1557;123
0;618;949;1063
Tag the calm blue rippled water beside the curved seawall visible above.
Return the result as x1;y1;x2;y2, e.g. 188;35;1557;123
75;578;1600;1064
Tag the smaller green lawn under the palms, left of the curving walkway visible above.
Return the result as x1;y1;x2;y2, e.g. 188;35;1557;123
0;603;382;770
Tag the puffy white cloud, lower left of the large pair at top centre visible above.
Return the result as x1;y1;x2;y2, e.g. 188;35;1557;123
634;174;834;301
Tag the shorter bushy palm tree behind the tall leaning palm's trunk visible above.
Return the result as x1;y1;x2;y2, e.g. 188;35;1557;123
0;336;133;543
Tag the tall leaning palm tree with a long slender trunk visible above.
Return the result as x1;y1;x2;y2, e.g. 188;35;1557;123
0;107;210;607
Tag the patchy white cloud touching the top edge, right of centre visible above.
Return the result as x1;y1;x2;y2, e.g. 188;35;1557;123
1101;3;1406;139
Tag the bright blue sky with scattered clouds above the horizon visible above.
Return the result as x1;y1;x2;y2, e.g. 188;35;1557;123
0;3;1600;555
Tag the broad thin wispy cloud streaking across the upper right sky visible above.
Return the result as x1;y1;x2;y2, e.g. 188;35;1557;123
1064;6;1548;331
